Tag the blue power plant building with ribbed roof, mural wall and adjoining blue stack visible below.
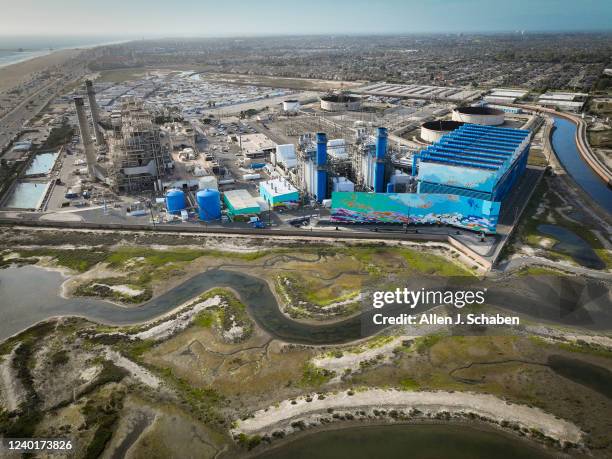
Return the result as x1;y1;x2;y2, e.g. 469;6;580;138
331;124;531;234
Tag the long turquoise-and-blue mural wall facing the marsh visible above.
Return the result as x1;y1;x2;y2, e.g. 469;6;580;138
331;192;500;233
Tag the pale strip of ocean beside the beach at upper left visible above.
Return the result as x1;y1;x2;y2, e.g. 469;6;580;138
0;35;129;68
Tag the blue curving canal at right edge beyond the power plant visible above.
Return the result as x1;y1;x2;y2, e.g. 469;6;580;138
552;116;612;213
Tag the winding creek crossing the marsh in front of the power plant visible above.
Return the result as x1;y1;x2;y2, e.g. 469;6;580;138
0;265;612;344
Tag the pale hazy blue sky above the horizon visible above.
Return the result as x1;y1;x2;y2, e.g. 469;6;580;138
0;0;612;37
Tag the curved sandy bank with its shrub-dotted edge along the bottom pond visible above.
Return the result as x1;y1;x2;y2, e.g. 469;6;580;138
230;388;584;452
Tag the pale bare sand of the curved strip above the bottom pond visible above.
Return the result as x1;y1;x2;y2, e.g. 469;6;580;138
233;389;582;443
